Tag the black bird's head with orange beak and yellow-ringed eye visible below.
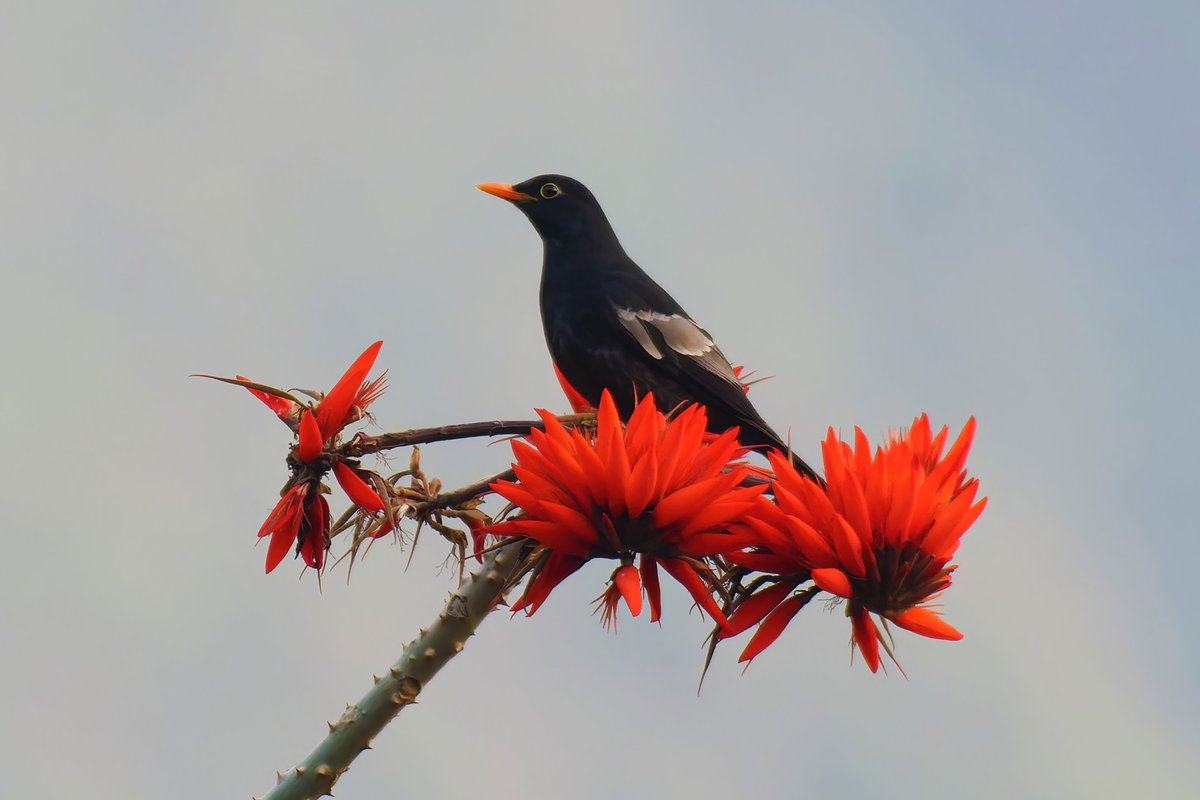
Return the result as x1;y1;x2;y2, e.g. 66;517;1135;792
476;175;616;243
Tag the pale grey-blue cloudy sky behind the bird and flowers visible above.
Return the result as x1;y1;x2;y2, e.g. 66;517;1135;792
0;2;1200;800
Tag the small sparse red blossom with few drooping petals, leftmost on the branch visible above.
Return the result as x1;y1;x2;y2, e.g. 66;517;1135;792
239;342;391;572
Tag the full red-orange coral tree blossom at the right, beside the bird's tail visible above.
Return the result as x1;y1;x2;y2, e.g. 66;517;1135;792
720;415;986;672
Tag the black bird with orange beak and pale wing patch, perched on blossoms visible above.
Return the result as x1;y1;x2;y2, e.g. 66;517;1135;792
479;175;820;480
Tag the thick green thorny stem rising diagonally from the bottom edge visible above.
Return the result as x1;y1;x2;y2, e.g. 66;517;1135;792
255;540;528;800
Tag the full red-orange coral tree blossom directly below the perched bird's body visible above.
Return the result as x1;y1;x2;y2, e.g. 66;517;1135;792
487;392;766;626
